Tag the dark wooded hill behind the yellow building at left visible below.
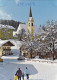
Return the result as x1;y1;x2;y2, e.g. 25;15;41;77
0;19;25;29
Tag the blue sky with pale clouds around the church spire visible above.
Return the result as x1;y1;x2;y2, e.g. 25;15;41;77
0;0;57;26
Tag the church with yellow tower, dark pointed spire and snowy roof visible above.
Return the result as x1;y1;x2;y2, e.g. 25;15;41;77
17;7;44;35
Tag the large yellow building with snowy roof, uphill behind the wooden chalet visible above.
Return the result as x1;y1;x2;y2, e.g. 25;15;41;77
0;24;15;40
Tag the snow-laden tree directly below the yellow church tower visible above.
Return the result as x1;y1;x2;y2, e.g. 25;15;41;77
20;34;38;58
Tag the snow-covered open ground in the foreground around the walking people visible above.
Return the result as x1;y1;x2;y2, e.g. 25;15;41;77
0;56;57;80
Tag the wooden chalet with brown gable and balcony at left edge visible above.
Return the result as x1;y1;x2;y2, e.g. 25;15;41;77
0;40;14;56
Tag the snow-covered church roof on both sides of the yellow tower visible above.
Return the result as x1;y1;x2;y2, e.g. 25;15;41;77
17;24;45;35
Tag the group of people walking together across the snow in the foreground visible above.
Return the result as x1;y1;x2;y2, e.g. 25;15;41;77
14;67;30;80
